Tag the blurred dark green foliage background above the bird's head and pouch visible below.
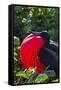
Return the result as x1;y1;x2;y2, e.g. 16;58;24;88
14;6;59;42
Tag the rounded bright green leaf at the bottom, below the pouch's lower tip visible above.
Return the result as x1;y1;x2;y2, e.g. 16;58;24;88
35;74;49;83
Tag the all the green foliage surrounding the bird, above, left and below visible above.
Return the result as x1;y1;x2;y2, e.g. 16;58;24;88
13;6;59;85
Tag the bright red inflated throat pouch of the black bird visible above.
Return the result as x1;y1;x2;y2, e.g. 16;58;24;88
20;34;47;73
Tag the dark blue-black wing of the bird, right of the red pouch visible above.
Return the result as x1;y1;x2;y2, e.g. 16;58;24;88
39;44;59;75
